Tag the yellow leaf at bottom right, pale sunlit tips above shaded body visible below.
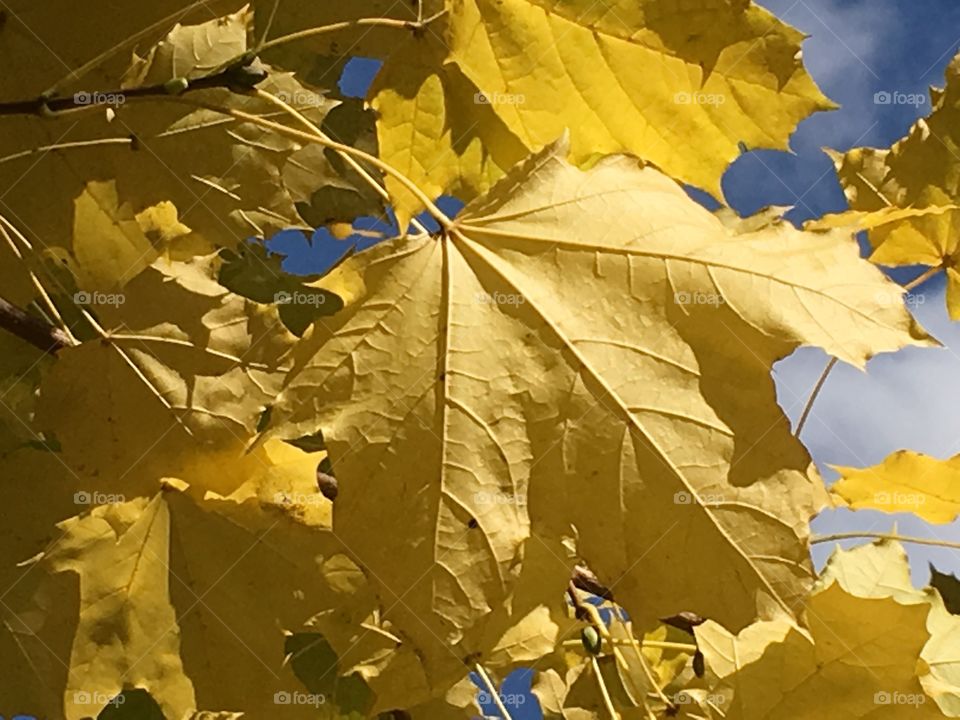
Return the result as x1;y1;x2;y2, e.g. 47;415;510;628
696;550;944;720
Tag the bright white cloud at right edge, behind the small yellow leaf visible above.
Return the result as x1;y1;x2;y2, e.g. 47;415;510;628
774;282;960;583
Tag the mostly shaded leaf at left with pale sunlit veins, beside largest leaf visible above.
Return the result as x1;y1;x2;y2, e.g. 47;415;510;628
37;256;294;484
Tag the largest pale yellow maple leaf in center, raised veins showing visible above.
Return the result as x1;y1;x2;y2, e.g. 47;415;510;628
262;136;929;692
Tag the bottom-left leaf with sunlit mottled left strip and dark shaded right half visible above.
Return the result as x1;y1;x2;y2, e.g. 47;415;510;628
4;489;361;720
